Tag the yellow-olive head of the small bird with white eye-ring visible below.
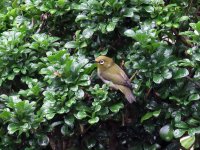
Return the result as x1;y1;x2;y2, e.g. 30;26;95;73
95;56;114;70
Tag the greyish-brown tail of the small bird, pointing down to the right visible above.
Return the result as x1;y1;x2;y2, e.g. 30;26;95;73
117;85;136;103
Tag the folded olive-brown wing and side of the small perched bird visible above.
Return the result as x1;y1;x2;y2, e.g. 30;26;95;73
100;64;131;88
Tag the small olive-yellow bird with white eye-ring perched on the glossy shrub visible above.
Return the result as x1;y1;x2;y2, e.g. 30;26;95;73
95;56;135;103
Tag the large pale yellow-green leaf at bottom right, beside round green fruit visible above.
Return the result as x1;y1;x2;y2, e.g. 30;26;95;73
180;136;195;149
